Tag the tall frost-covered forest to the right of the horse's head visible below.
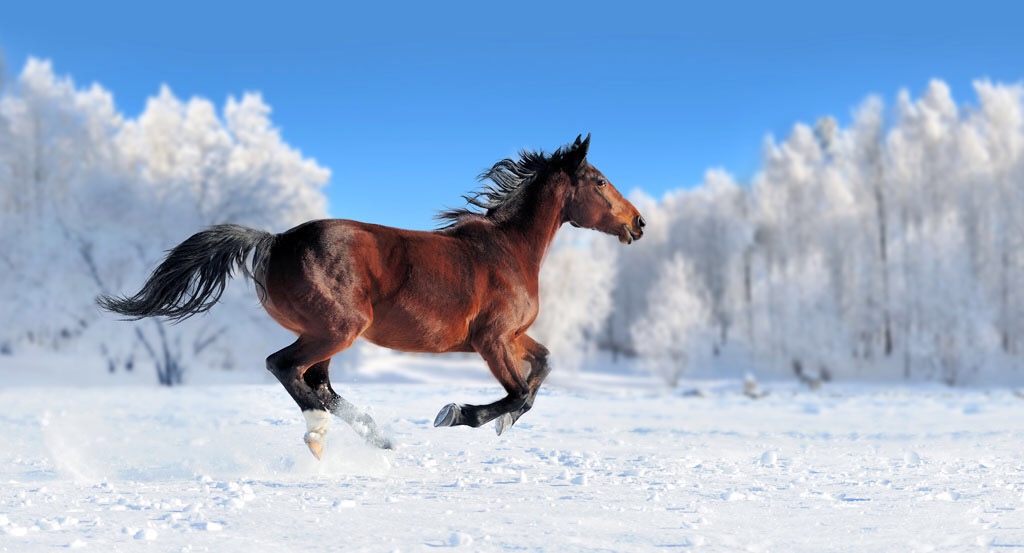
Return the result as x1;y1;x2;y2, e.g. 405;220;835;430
601;81;1024;383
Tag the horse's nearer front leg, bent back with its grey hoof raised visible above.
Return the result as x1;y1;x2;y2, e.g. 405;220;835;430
434;333;529;428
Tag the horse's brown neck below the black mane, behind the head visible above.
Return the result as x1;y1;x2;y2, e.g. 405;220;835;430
497;176;568;272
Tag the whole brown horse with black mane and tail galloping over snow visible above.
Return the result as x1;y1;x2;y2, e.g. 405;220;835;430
98;135;644;459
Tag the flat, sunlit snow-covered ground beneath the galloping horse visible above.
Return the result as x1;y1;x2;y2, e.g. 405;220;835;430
0;359;1024;552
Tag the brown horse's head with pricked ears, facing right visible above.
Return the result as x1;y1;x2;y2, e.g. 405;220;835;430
564;134;646;244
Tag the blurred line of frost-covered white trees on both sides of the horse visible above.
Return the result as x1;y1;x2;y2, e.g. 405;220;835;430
0;59;1024;384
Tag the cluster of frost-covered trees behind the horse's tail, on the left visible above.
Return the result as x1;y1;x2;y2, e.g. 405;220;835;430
0;59;329;384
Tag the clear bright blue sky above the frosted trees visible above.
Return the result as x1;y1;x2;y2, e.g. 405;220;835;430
0;1;1024;228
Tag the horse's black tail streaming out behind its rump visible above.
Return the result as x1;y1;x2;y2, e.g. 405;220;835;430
96;224;274;321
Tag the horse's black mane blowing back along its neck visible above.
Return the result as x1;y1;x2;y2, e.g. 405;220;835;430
434;136;590;229
